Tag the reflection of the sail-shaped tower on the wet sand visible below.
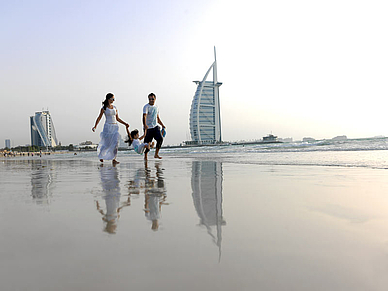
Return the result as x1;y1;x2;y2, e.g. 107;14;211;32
191;161;226;258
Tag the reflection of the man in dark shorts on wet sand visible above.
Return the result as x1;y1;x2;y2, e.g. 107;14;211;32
144;161;167;231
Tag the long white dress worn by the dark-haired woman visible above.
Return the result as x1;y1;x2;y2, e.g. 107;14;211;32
97;106;120;160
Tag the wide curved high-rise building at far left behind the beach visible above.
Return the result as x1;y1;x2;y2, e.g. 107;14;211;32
30;110;58;147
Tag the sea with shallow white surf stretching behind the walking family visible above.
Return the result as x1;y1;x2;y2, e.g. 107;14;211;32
5;137;388;169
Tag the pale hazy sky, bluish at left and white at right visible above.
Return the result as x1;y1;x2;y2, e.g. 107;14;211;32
0;0;388;147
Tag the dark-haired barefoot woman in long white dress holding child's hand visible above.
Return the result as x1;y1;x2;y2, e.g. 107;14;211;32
92;93;129;164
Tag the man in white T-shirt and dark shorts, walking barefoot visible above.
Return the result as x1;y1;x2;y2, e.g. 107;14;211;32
143;93;166;160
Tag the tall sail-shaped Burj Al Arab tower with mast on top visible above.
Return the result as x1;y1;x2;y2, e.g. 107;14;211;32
190;47;222;144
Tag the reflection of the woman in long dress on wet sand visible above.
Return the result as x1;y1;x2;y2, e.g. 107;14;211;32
96;166;130;234
